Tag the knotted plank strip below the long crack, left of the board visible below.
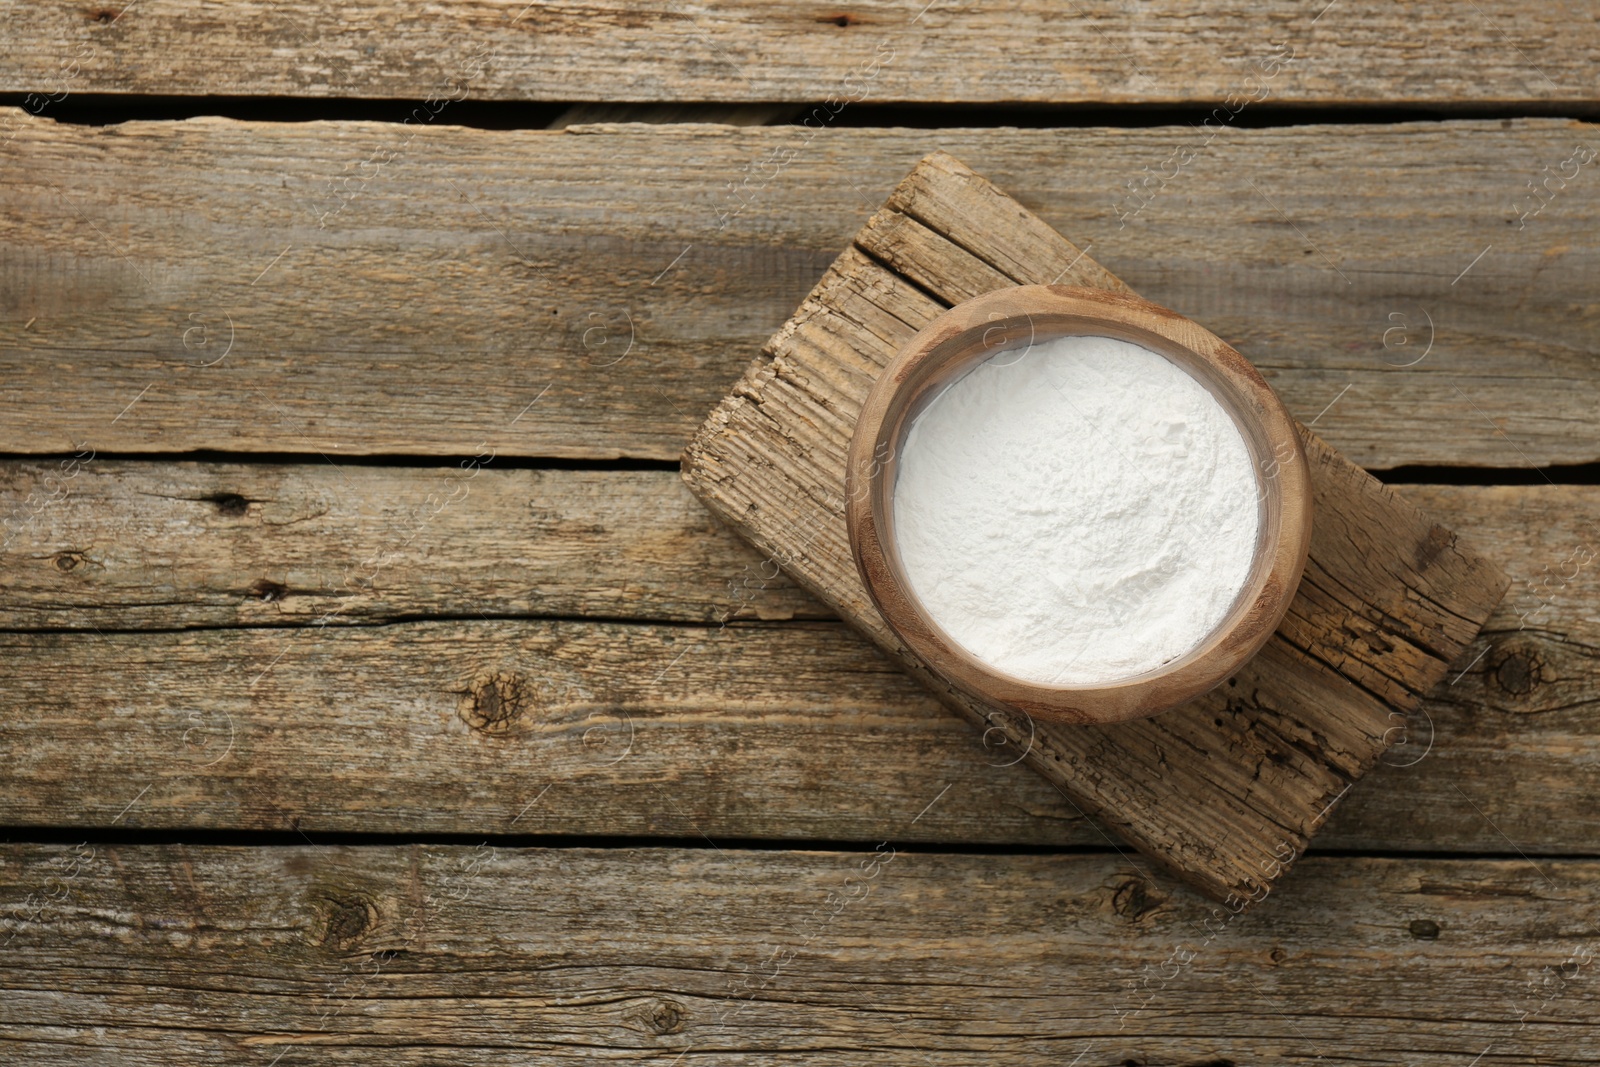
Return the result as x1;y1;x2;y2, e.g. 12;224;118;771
0;619;1075;841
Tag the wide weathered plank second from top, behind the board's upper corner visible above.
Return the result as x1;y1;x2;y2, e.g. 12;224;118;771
0;115;1600;469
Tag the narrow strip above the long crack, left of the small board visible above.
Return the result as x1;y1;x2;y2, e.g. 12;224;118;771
0;456;830;630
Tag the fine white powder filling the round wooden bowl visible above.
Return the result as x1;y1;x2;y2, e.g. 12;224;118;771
894;338;1259;685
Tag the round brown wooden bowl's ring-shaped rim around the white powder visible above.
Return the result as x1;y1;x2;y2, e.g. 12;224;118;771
845;285;1310;723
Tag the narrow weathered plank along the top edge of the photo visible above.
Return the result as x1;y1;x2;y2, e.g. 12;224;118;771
0;0;1600;107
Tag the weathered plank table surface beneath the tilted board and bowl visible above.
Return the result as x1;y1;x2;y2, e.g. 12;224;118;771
0;0;1600;1067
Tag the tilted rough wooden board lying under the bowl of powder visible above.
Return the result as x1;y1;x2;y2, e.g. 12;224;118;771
683;152;1509;899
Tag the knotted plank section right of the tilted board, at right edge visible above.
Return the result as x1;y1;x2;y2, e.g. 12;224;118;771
1318;485;1600;853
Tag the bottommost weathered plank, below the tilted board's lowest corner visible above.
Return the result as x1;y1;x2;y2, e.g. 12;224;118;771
0;844;1600;1067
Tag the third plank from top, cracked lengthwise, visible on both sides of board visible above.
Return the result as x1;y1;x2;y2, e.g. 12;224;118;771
0;461;1580;853
